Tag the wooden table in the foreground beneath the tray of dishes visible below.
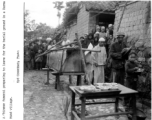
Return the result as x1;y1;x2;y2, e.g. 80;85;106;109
70;84;138;120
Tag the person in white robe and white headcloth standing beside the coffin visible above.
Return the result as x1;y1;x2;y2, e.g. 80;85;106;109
92;37;107;83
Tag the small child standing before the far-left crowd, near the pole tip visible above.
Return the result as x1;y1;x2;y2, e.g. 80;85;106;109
35;49;43;70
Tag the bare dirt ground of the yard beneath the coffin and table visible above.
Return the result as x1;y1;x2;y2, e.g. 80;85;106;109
24;70;150;120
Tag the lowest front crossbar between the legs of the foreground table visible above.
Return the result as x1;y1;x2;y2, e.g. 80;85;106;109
85;112;133;119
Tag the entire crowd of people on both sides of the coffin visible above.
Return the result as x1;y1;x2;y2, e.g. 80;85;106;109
24;24;151;111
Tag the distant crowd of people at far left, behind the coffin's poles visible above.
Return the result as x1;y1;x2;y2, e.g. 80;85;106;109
24;40;48;70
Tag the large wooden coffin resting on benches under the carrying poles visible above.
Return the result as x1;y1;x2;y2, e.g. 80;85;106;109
47;48;91;73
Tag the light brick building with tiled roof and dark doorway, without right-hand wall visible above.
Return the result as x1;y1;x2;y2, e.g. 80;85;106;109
65;1;117;40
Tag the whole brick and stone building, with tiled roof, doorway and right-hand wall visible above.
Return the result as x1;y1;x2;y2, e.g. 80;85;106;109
65;1;151;59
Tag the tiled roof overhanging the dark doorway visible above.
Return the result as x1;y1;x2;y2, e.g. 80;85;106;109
63;1;125;26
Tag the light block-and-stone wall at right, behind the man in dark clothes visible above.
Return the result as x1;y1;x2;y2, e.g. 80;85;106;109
114;1;151;60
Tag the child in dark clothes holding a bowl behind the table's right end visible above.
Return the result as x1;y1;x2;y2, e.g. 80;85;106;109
124;52;139;106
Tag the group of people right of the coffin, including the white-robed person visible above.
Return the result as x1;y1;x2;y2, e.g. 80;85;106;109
61;24;147;110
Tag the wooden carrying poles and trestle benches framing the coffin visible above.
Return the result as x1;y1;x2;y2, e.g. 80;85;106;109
37;39;100;90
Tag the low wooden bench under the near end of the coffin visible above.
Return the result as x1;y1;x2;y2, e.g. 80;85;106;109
51;72;85;90
